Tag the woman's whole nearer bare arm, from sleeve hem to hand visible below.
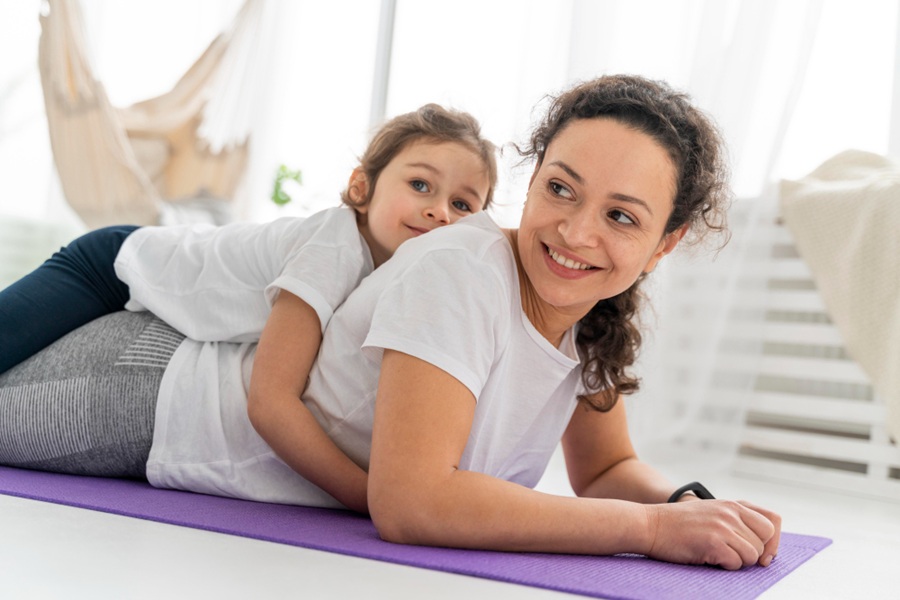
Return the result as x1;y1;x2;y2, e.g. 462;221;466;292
369;350;773;568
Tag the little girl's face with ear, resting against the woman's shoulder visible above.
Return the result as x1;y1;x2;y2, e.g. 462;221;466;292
350;140;490;266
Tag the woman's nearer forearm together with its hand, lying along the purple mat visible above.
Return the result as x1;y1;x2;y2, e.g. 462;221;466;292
369;471;780;569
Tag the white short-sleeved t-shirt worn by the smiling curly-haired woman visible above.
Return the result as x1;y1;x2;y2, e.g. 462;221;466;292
147;213;581;506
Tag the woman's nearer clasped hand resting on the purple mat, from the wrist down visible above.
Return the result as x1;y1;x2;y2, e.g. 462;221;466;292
646;500;781;570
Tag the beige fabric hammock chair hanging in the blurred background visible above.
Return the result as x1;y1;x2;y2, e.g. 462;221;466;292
38;0;265;229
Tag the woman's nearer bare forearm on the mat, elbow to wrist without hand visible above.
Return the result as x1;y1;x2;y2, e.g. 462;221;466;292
369;470;653;554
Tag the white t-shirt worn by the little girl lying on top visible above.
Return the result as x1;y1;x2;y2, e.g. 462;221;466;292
115;206;374;342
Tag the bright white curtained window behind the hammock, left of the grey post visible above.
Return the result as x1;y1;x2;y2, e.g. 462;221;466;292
0;0;378;230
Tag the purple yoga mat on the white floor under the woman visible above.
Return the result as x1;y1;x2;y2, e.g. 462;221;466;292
0;467;831;600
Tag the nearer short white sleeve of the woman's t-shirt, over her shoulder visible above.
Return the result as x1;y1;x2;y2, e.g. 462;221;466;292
363;250;510;398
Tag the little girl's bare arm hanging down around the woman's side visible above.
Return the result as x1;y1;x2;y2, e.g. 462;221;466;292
247;290;368;513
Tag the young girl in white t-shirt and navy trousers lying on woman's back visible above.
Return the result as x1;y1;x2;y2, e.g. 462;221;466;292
0;104;497;510
